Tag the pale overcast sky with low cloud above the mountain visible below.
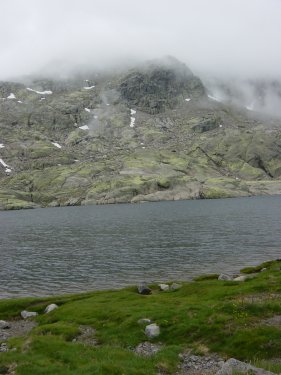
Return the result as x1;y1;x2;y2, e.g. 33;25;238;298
0;0;281;79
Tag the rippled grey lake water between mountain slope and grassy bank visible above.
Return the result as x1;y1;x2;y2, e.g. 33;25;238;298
0;196;281;298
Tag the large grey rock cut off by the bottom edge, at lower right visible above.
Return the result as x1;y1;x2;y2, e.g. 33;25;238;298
216;358;274;375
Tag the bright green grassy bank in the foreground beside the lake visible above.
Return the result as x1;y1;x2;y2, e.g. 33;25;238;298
0;261;281;375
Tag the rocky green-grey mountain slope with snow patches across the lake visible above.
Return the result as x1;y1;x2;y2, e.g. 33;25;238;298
0;58;281;209
